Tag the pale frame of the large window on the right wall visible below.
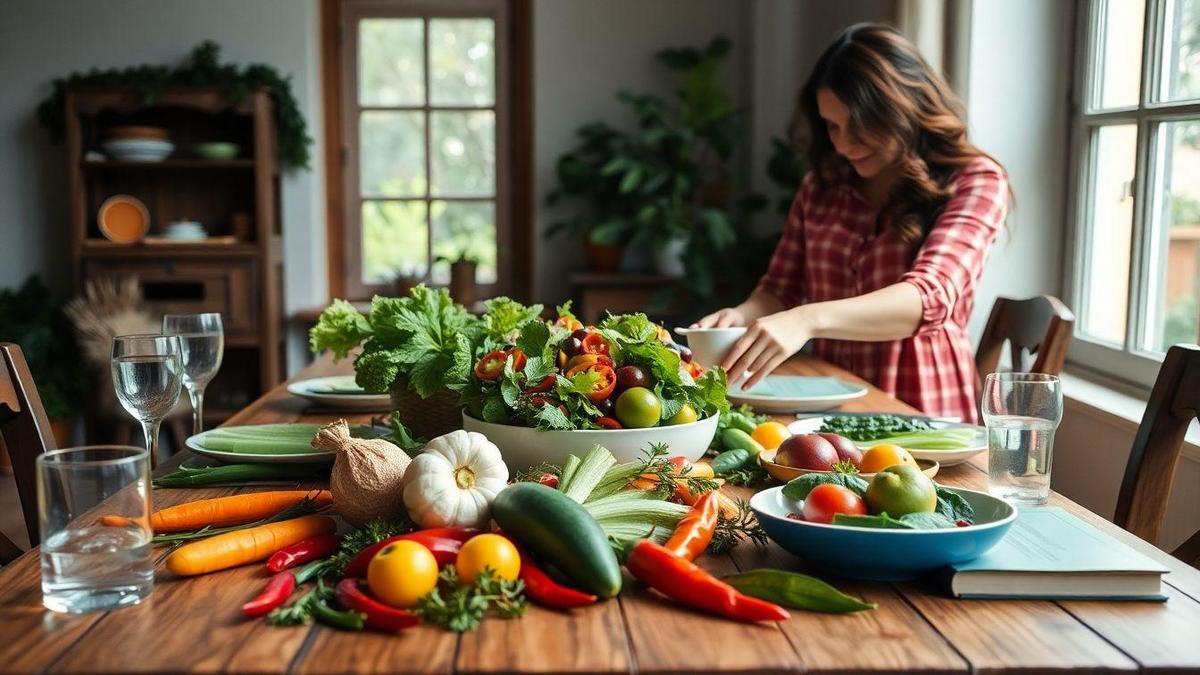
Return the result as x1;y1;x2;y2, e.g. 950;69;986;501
1063;0;1200;389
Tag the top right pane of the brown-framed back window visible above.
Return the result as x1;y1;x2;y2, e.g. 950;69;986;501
430;19;496;106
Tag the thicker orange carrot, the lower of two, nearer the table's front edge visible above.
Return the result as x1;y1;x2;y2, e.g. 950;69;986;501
167;515;337;577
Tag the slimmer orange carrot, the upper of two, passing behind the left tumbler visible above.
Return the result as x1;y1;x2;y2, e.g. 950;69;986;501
150;490;334;533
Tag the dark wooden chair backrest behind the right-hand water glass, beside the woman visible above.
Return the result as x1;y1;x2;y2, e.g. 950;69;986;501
976;295;1075;381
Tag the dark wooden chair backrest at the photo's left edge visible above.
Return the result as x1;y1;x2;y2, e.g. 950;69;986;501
0;342;55;546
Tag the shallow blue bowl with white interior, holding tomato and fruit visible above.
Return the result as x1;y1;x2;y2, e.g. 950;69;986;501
750;486;1016;581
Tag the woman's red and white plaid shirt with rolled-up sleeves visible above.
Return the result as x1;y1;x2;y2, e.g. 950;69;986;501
760;157;1008;422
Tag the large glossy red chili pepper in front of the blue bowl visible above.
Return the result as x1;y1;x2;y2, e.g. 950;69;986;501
625;539;790;621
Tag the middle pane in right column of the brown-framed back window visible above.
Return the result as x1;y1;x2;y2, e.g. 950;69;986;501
430;110;496;197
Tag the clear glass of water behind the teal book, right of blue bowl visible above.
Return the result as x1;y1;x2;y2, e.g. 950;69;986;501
983;372;1062;504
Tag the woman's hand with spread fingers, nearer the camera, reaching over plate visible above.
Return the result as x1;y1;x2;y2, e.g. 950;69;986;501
720;305;812;389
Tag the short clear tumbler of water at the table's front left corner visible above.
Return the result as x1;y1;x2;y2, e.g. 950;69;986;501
37;446;154;614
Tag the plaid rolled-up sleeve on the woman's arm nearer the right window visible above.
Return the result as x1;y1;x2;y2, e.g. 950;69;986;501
900;159;1008;335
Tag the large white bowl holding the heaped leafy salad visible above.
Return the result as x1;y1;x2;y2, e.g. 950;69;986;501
462;412;718;471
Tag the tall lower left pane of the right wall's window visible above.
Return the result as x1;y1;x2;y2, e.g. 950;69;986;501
1081;124;1138;345
